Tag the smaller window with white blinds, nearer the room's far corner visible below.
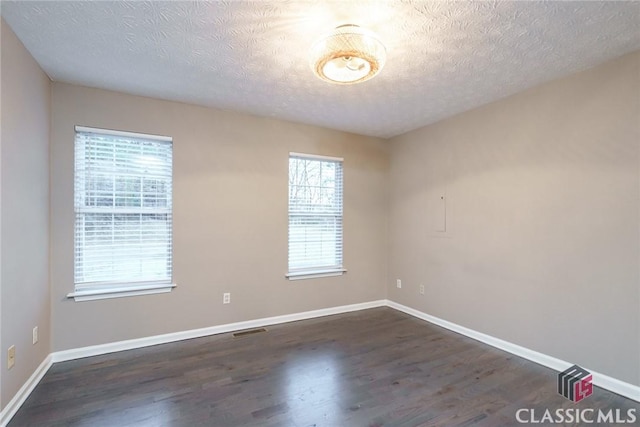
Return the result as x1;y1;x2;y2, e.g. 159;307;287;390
287;153;346;279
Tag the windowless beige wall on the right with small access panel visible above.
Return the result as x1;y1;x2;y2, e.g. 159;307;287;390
388;53;640;385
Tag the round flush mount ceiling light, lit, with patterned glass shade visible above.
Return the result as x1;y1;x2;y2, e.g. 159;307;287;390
311;24;387;84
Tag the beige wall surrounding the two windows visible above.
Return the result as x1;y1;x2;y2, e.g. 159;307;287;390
51;83;388;351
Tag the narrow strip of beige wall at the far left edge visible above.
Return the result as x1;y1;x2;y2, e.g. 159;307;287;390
0;21;51;408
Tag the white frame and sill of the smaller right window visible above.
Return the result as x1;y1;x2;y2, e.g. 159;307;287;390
285;152;347;280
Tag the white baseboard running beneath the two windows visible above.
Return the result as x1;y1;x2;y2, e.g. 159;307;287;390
51;300;387;363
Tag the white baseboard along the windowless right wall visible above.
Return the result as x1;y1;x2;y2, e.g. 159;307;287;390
387;300;640;402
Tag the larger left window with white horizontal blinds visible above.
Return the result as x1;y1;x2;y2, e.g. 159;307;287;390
69;126;174;301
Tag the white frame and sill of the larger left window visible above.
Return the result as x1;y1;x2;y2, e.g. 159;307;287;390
67;126;177;301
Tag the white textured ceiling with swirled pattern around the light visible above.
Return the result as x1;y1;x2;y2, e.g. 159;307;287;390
0;0;640;137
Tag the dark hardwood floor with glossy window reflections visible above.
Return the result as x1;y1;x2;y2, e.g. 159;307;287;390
9;308;640;427
